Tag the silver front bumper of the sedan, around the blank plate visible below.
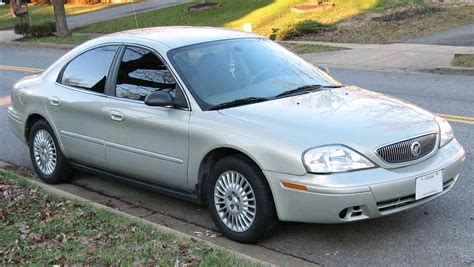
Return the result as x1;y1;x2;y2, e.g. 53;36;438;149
264;139;465;223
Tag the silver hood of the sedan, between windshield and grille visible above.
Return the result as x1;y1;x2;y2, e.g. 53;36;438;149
220;86;438;157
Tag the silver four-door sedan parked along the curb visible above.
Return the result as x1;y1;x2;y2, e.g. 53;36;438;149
8;27;465;242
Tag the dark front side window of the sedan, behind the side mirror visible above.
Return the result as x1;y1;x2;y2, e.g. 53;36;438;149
115;47;176;101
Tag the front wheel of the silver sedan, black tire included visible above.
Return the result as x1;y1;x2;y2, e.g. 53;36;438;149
205;155;278;243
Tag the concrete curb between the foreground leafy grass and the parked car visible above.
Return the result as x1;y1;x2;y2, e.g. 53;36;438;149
0;164;276;266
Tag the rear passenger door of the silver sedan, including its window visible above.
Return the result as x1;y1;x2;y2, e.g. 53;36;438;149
45;45;120;167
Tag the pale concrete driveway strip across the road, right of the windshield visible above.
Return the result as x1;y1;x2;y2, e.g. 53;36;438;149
299;41;474;72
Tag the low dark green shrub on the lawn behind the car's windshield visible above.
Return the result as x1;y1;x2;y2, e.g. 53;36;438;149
276;20;334;40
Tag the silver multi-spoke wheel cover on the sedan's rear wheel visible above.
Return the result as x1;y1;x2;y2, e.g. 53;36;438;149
33;130;57;175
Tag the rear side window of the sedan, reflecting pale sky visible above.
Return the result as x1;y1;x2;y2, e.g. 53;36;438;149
61;45;119;93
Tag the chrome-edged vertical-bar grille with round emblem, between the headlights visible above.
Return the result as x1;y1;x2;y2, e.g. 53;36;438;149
377;134;436;163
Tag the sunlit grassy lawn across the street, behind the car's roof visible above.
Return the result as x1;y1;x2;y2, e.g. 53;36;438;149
23;0;474;44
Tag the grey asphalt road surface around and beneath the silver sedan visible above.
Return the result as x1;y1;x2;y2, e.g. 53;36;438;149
0;46;474;266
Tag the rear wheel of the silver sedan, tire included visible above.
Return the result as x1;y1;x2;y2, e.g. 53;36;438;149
28;120;73;184
